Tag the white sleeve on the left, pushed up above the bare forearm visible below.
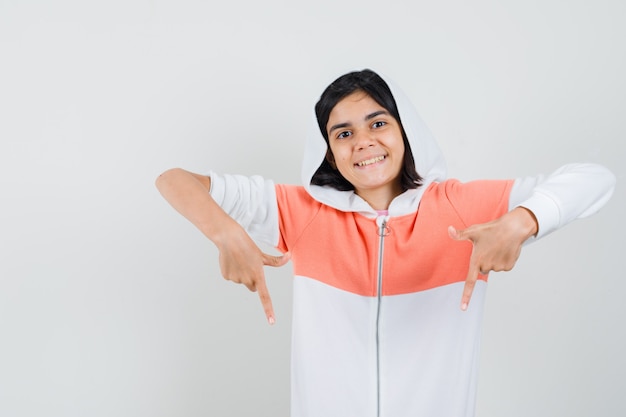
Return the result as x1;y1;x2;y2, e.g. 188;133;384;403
209;171;279;246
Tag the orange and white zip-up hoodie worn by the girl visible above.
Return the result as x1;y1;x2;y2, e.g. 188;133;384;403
206;73;615;417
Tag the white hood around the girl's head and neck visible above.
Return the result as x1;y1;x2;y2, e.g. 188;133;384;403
302;73;446;217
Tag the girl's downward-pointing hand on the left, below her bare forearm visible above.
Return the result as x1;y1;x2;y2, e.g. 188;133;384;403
217;224;291;324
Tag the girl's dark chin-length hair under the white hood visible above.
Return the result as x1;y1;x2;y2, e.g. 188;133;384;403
311;69;422;191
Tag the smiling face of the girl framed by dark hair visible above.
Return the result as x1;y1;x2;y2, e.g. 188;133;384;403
326;91;404;201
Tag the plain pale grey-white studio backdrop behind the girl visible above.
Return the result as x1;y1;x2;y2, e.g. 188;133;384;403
0;0;626;417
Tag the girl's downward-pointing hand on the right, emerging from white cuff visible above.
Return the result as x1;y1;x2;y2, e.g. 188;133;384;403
448;207;538;311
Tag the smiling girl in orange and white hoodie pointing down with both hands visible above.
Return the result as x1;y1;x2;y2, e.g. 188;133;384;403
157;70;615;417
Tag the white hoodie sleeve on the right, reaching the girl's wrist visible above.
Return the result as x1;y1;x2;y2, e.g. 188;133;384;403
509;164;615;239
